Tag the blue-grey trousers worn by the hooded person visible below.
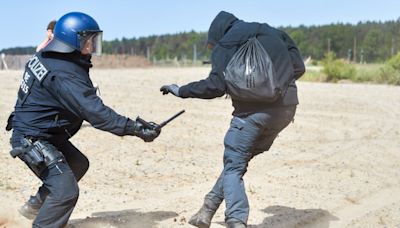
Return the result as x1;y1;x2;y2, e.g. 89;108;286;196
206;106;296;224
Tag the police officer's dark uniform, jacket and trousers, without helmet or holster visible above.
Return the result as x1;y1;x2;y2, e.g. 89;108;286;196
10;51;145;227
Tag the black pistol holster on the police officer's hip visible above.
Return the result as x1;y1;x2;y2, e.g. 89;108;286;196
10;138;65;167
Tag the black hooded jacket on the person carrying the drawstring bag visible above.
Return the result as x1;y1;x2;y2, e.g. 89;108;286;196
179;11;305;116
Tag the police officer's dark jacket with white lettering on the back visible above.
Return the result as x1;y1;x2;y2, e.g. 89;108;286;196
12;52;133;145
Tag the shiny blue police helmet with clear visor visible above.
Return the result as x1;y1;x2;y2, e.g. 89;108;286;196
43;12;103;55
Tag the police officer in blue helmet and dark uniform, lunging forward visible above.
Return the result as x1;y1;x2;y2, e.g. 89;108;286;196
8;12;160;228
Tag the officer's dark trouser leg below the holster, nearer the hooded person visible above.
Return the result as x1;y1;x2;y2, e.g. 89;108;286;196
33;141;89;228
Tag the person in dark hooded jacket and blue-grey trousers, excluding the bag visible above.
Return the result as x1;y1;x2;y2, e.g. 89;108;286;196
160;11;305;228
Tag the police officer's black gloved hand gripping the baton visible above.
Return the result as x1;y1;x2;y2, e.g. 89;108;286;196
126;120;161;142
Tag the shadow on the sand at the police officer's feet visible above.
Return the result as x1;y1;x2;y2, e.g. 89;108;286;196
67;209;178;228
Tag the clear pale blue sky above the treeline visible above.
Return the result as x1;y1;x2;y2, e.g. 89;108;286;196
0;0;400;50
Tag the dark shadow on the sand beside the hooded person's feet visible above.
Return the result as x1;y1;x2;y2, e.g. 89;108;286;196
248;205;338;228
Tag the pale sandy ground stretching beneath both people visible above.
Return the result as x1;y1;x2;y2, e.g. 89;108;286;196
0;68;400;228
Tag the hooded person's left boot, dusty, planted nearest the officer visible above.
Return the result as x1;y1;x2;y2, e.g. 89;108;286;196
189;198;219;228
